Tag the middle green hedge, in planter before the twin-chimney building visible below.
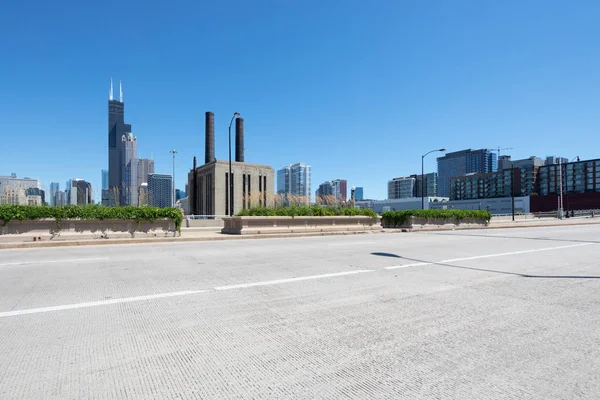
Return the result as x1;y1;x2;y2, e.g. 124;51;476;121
237;205;377;218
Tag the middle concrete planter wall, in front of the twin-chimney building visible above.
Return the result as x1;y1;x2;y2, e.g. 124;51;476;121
221;216;381;235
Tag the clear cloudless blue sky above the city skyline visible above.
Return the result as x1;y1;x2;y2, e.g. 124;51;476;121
0;0;600;198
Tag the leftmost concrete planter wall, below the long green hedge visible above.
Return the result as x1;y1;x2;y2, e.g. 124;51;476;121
0;218;177;243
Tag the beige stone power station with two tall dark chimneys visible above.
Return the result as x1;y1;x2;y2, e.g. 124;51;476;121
187;112;275;215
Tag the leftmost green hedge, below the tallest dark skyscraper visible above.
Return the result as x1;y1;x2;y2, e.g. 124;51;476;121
0;205;183;231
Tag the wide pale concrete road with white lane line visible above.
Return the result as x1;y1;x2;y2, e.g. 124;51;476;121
0;226;600;399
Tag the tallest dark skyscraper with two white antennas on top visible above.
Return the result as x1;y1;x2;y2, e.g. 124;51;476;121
107;79;135;208
